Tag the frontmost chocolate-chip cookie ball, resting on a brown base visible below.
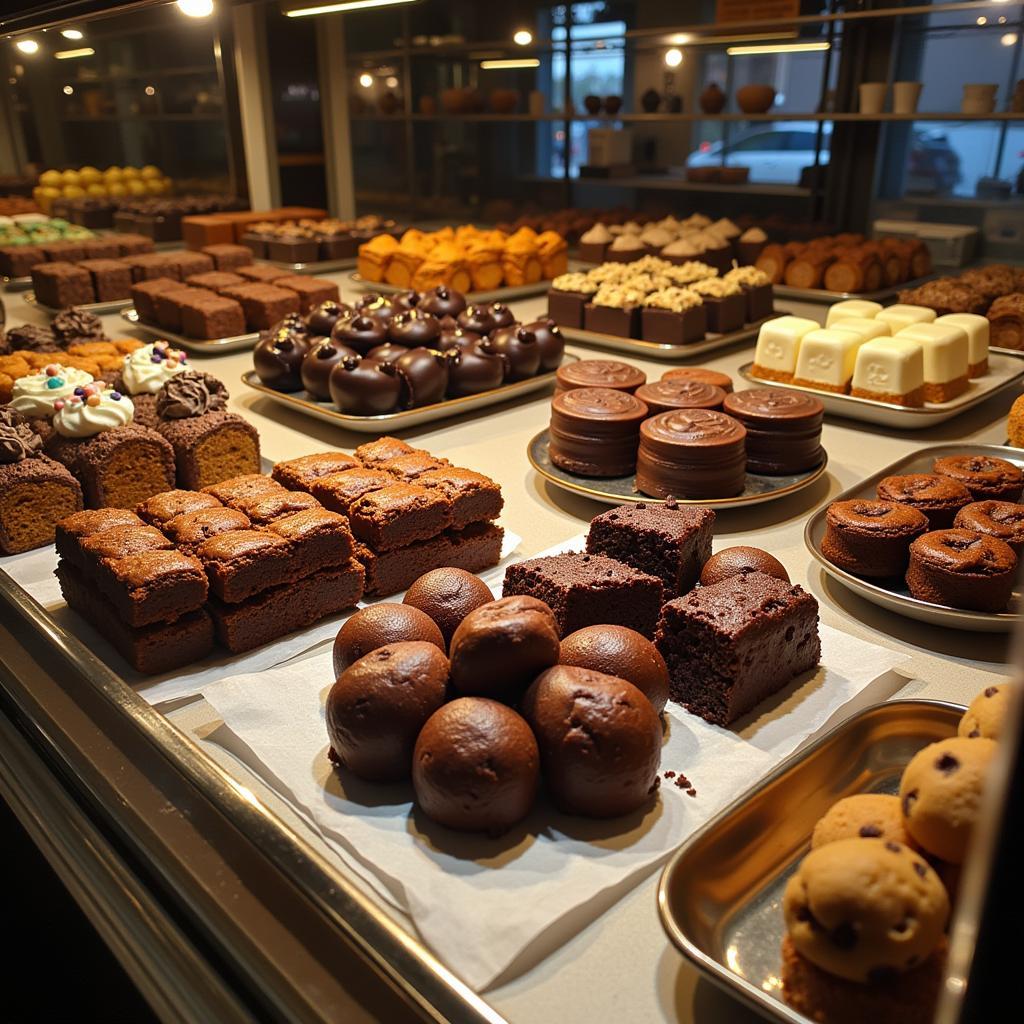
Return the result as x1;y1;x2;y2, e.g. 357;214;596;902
782;839;949;983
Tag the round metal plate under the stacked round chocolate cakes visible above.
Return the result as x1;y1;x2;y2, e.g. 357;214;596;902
526;430;828;509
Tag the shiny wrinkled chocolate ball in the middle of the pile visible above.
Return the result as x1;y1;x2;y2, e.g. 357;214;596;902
451;595;559;700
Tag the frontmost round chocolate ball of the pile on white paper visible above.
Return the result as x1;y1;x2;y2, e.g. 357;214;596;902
413;697;540;836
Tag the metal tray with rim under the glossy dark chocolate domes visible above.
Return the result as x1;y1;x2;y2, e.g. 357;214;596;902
242;352;580;434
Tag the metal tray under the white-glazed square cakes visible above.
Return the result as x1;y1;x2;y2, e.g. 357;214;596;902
739;352;1024;430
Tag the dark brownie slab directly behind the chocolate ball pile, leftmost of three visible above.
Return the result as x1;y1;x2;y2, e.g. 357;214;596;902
502;553;662;637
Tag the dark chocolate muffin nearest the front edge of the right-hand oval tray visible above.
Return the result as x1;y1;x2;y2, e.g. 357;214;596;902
906;529;1017;611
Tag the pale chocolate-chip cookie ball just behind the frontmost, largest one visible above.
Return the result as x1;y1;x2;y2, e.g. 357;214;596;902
899;736;995;864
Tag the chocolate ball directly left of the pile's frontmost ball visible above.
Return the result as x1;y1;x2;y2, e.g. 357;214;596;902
326;640;447;782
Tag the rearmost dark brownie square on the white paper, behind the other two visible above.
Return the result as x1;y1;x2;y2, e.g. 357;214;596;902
587;502;715;600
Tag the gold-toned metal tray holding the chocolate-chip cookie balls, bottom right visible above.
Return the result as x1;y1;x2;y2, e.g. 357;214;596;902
657;700;965;1024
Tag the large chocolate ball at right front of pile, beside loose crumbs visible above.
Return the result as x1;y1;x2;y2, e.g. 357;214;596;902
522;665;662;818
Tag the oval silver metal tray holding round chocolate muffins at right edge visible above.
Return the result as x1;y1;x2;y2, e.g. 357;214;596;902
804;444;1024;633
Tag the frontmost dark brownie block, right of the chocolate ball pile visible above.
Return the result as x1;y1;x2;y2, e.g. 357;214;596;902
654;572;821;725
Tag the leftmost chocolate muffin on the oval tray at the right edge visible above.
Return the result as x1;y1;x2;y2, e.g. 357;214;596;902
821;498;931;578
